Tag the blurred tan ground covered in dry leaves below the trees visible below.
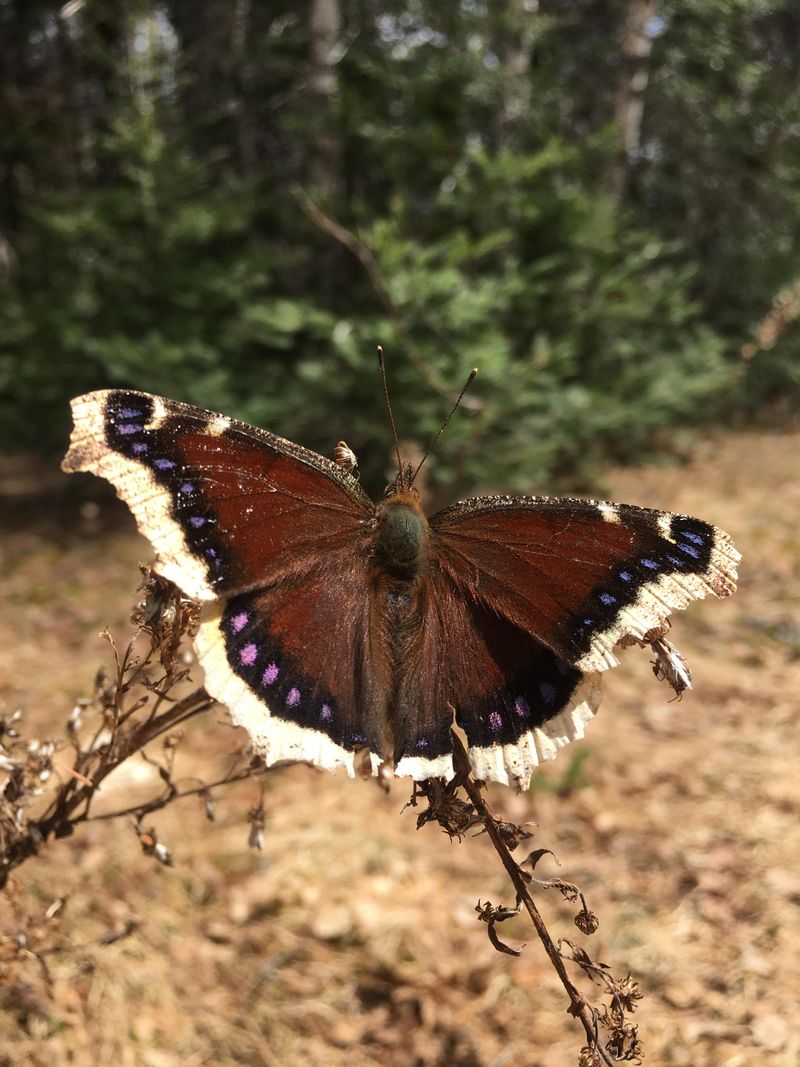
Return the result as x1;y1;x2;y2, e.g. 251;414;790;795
0;434;800;1067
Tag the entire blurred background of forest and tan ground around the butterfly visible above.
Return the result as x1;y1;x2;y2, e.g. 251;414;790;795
0;0;800;1067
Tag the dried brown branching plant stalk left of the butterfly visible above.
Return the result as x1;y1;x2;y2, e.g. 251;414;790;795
0;568;265;888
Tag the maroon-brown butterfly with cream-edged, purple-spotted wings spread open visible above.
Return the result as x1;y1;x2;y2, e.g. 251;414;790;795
63;389;740;789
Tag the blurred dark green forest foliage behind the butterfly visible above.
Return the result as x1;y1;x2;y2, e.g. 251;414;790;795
0;0;800;496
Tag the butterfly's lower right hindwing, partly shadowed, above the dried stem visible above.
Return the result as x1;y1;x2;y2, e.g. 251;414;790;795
393;560;599;789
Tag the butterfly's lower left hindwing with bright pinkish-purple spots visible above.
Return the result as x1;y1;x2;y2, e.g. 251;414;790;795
196;552;390;776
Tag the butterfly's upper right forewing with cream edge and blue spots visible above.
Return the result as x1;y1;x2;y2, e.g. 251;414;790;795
430;497;740;672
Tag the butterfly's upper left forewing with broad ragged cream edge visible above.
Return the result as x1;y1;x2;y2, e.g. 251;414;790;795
63;389;374;600
